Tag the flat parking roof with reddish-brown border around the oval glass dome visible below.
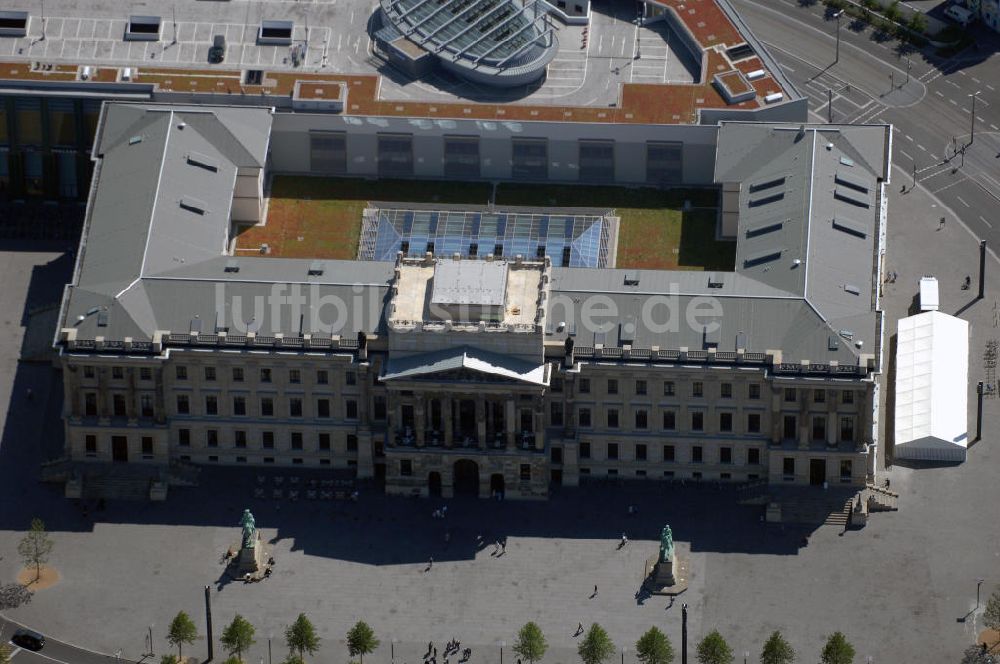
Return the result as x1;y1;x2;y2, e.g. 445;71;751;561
0;0;799;124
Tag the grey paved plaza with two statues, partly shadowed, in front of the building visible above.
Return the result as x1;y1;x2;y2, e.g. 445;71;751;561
0;171;1000;664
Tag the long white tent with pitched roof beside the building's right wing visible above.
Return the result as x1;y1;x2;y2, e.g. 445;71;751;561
895;311;969;461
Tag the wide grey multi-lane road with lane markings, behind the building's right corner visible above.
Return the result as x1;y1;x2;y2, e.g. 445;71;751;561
733;0;1000;248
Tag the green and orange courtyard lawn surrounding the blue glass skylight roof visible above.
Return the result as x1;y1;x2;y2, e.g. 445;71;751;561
237;175;736;270
